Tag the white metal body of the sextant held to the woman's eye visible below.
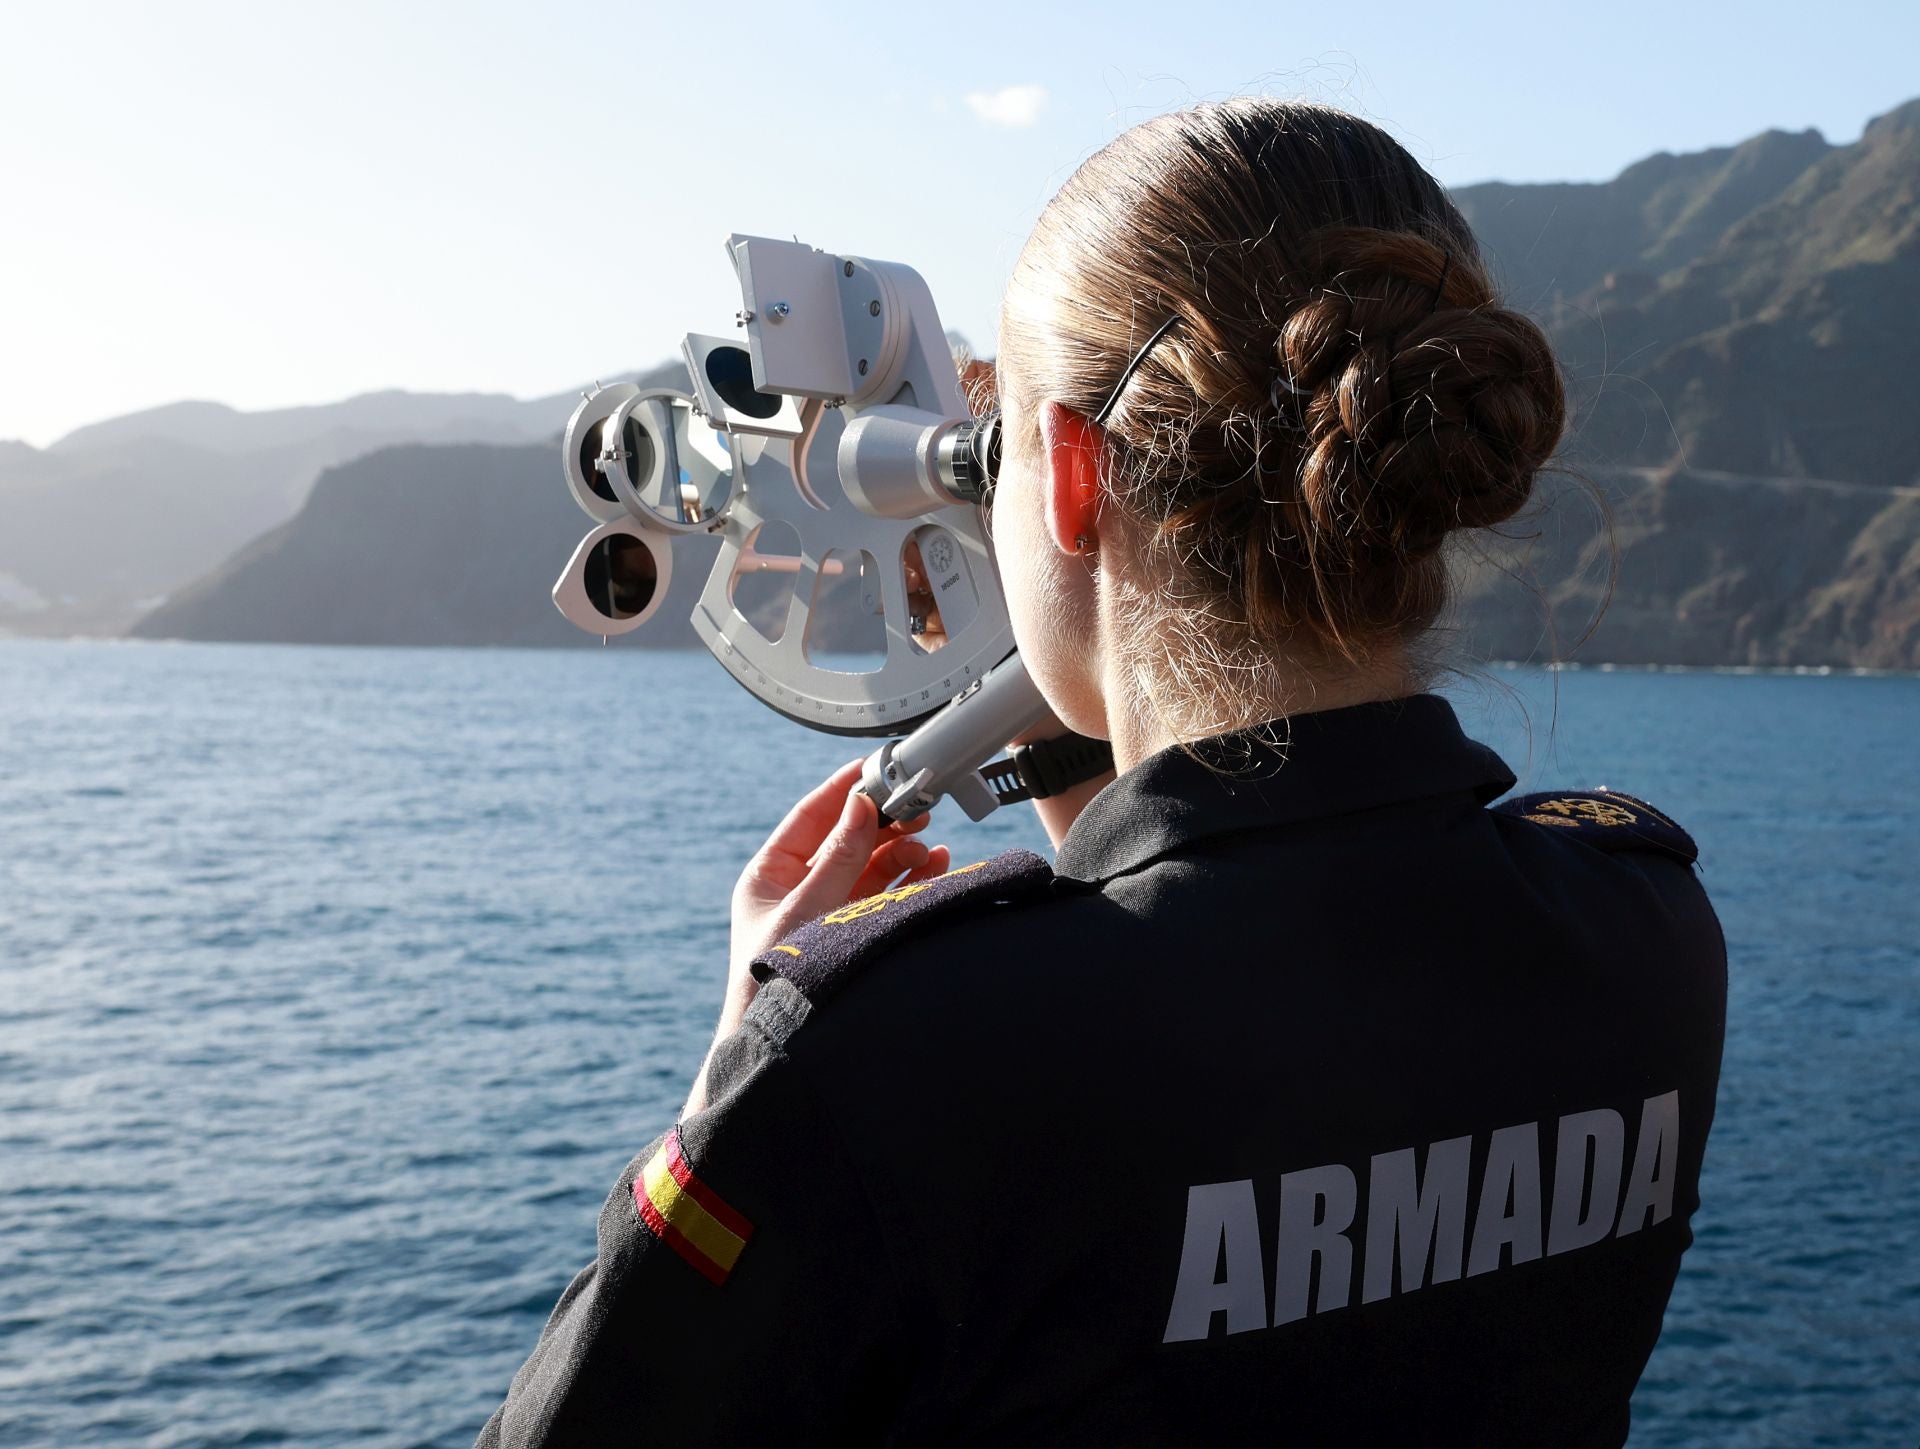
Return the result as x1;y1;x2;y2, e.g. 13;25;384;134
555;236;1046;818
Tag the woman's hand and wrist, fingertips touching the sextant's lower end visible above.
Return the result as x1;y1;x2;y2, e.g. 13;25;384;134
687;760;950;1113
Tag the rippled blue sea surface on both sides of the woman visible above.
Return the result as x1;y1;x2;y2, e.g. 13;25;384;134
0;643;1920;1449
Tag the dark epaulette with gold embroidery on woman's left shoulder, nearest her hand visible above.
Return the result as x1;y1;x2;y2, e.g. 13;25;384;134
753;850;1054;1006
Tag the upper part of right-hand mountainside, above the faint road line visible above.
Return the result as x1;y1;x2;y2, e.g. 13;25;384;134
1457;100;1920;484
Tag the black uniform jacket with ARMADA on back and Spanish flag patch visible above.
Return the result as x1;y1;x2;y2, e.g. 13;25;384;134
480;697;1726;1447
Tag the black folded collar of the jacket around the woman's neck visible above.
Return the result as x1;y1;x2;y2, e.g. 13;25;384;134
1054;695;1513;881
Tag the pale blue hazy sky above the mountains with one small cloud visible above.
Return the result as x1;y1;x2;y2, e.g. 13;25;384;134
0;0;1920;445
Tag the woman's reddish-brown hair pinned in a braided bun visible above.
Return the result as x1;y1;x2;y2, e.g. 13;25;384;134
1000;100;1567;727
